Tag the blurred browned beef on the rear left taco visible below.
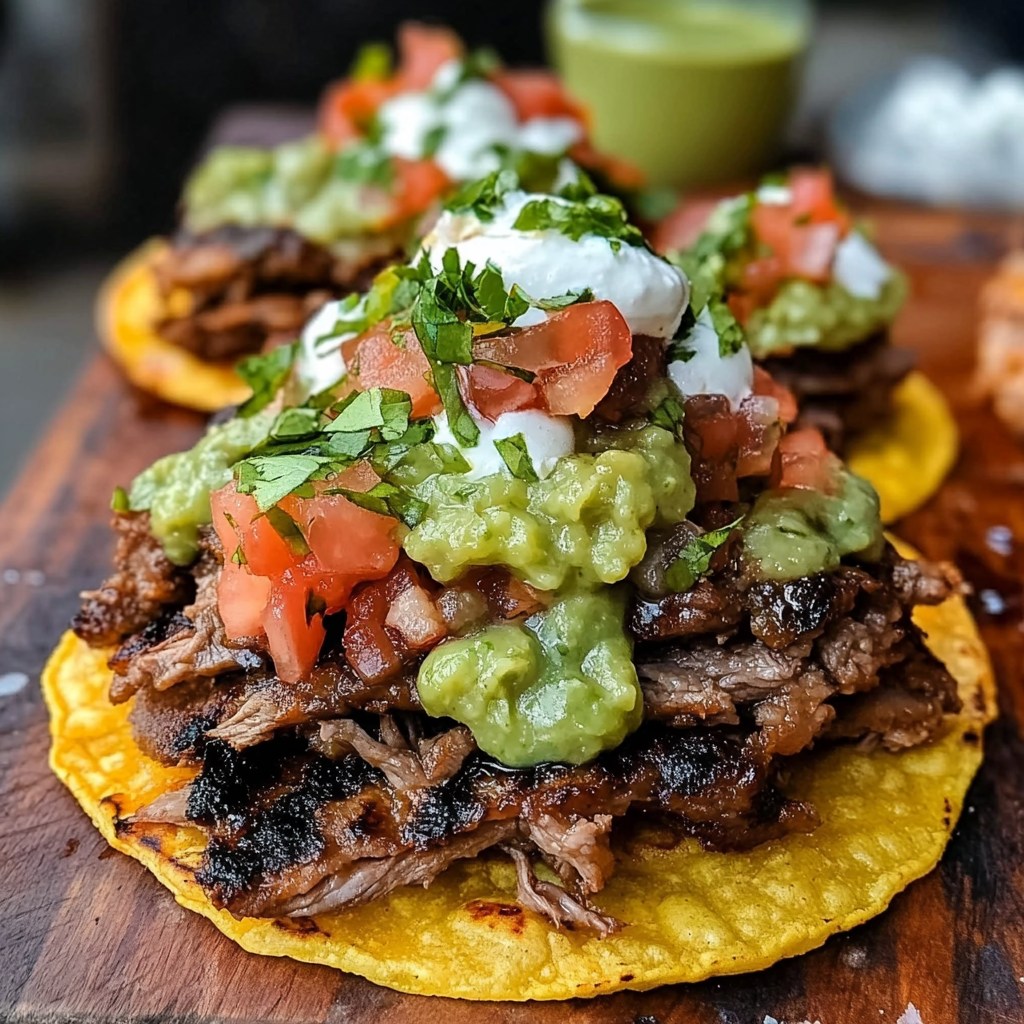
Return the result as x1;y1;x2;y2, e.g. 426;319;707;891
156;225;400;359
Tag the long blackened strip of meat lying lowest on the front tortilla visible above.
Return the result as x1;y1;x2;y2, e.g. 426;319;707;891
176;727;814;915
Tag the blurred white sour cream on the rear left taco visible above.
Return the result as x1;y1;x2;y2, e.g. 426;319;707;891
378;60;584;181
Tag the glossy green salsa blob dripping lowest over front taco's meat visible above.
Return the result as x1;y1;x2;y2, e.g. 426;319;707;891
417;589;643;767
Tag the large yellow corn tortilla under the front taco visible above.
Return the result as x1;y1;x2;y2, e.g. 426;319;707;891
43;552;995;999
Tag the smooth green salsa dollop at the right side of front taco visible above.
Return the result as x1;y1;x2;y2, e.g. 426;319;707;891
740;470;884;580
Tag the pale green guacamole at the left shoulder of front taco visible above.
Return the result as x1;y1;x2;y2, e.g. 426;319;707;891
128;412;273;565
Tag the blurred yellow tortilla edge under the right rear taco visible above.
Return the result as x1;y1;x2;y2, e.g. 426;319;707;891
846;372;959;522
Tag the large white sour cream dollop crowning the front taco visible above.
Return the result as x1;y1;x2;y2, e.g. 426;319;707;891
415;191;689;338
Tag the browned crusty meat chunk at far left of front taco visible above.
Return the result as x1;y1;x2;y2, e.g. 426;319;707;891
72;512;195;647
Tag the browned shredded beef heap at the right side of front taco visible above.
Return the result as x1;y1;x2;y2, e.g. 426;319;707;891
637;553;958;756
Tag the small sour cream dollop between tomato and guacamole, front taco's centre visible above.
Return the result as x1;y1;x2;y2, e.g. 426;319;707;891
434;409;575;480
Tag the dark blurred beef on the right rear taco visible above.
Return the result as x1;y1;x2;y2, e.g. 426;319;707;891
762;333;914;453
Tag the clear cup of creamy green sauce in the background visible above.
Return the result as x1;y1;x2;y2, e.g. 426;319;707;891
547;0;810;187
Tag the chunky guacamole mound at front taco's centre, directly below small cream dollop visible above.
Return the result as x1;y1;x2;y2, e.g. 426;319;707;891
404;426;694;590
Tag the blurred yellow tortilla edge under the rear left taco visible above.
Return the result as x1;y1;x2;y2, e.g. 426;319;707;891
96;239;250;413
